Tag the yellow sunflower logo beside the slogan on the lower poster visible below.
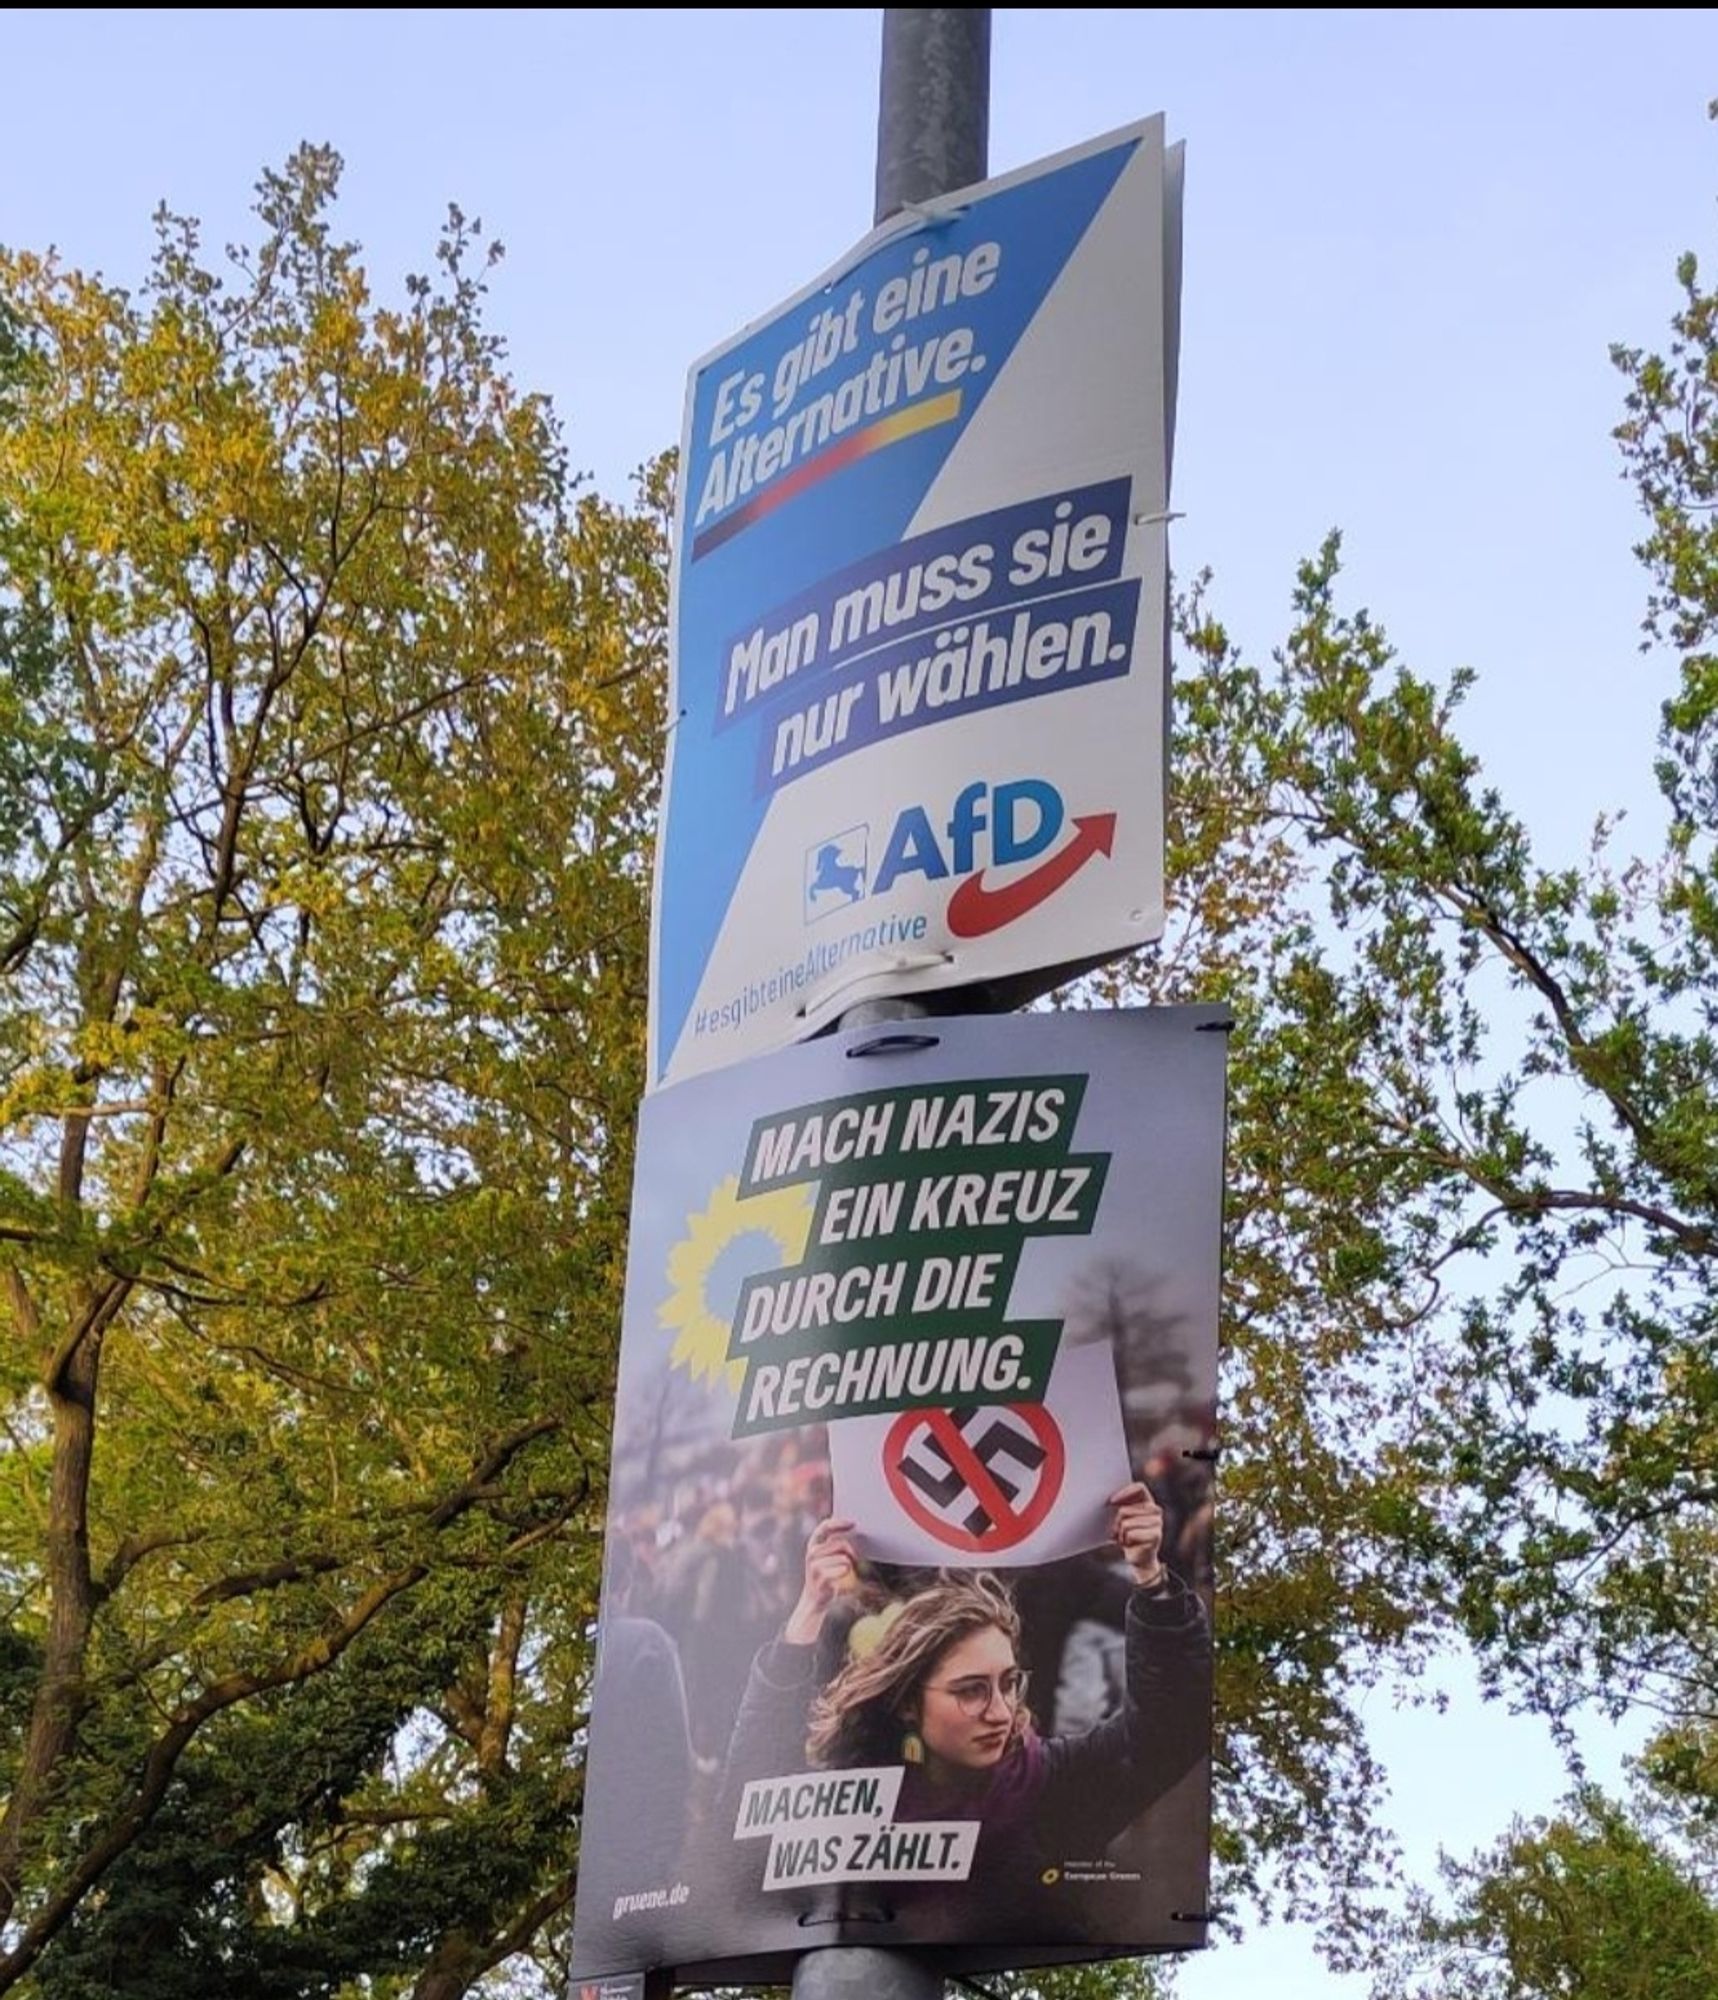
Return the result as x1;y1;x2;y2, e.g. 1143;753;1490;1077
656;1174;812;1390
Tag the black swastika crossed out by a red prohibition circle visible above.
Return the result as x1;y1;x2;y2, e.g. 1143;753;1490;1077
882;1402;1066;1556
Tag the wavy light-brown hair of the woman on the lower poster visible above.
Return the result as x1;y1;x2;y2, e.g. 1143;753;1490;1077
806;1570;1026;1768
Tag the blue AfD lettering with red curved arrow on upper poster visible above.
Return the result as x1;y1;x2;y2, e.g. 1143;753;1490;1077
870;778;1116;938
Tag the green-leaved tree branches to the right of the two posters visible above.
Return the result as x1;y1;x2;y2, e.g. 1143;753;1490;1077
1112;129;1718;1982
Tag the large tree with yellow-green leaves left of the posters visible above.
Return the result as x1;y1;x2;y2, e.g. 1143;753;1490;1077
0;148;666;2000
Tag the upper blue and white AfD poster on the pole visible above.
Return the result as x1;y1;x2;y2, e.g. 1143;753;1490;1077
648;118;1182;1088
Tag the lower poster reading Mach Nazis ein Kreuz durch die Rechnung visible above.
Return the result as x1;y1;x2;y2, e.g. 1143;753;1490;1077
572;1006;1228;1994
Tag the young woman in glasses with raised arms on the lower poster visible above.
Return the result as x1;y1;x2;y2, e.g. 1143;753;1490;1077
728;1482;1210;1936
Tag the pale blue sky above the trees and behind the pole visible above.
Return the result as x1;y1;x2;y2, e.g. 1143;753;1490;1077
0;8;1718;2000
